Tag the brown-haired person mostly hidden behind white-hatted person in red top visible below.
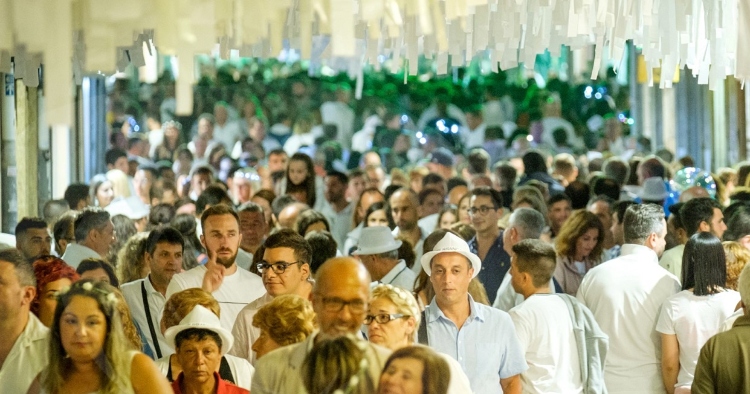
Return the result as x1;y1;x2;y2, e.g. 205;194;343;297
156;288;255;390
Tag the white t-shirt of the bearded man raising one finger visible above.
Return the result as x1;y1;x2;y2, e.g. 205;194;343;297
166;265;266;331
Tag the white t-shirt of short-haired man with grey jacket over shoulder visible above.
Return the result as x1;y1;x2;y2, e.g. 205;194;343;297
508;294;583;394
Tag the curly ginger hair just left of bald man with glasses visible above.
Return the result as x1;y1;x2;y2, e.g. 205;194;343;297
253;294;316;346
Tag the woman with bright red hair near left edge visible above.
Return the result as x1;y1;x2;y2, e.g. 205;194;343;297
31;256;78;327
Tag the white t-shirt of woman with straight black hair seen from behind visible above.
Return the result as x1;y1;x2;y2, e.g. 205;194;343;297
656;290;740;387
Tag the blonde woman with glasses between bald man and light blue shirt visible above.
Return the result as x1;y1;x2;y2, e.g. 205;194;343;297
364;284;471;394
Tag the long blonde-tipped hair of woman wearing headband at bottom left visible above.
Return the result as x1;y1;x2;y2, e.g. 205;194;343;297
41;280;131;394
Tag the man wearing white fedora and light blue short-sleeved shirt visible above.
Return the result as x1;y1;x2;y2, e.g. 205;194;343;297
419;233;528;394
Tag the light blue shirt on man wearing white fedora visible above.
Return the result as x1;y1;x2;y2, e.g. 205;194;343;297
425;295;528;394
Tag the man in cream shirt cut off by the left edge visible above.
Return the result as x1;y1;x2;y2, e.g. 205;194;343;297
0;249;49;393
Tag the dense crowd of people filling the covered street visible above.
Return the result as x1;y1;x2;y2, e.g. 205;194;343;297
0;66;750;394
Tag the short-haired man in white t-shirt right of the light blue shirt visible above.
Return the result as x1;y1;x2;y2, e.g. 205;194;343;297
506;239;585;394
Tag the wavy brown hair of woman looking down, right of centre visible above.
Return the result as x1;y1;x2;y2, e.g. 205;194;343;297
555;209;604;261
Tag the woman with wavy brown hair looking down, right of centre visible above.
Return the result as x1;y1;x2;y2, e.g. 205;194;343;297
554;210;604;296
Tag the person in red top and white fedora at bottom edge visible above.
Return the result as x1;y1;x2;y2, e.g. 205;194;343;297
164;305;250;394
